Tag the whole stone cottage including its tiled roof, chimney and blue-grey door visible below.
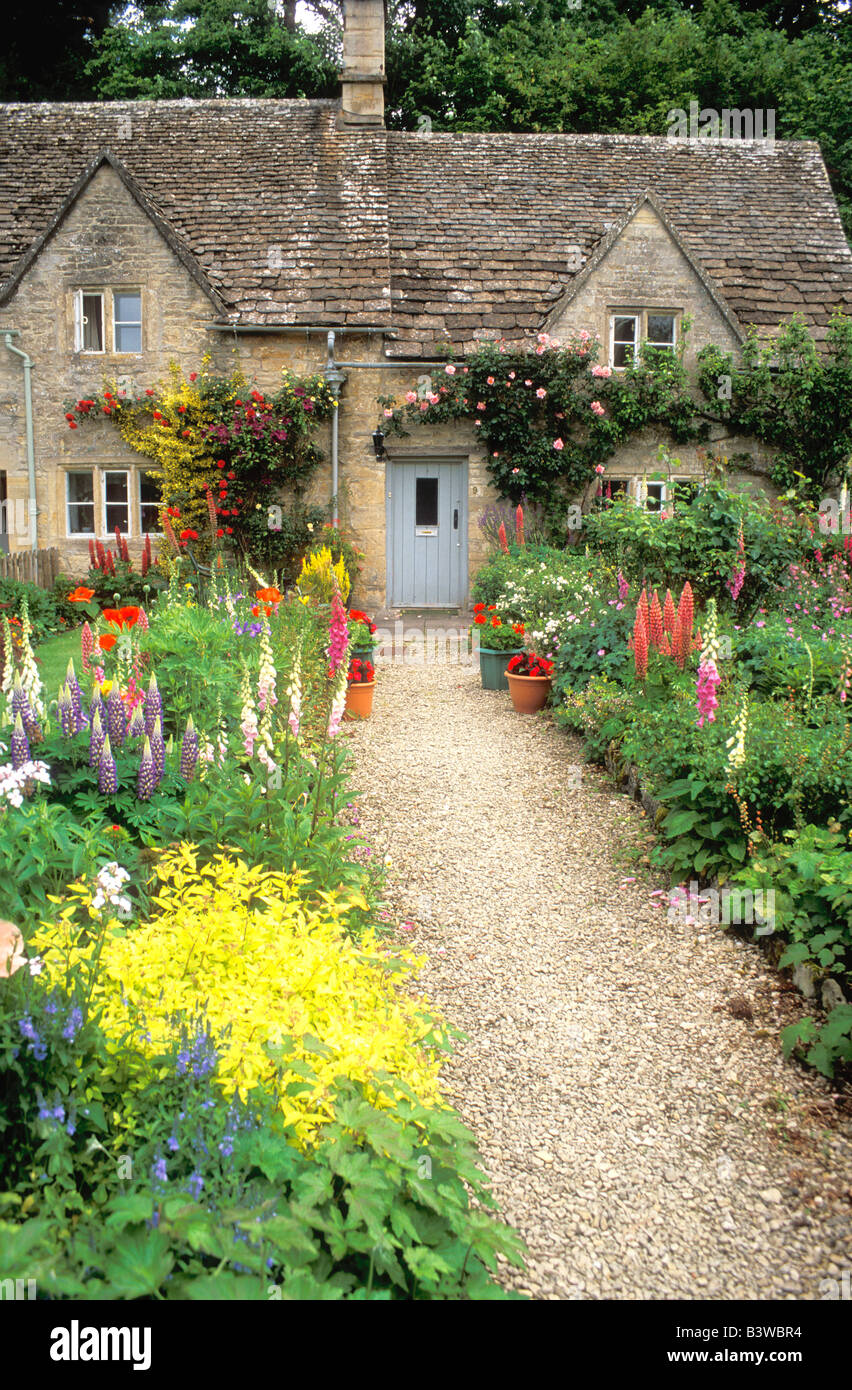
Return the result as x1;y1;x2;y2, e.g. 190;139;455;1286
0;0;852;609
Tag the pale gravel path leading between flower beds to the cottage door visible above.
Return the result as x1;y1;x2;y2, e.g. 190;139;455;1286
345;664;852;1300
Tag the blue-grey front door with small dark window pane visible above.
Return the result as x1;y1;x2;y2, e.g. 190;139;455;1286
388;459;467;607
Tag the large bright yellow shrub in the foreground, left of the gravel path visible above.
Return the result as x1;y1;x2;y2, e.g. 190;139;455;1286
32;844;443;1147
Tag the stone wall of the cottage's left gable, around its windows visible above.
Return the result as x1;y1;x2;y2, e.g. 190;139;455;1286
0;165;215;574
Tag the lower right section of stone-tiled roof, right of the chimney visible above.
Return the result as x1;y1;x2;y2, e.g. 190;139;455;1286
386;132;852;350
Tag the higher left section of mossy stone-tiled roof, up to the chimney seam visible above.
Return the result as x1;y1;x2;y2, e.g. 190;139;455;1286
0;100;391;324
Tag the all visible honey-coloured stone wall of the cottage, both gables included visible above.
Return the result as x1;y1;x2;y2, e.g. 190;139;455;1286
0;165;769;610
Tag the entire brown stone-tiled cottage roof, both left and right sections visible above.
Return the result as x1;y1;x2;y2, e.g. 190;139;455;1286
0;99;852;356
